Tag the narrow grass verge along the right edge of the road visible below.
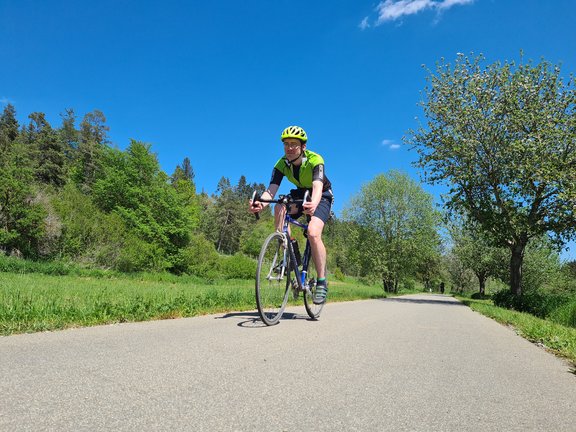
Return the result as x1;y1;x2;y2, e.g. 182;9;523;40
458;297;576;367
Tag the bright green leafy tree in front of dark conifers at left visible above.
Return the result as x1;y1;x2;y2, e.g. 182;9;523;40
92;140;193;270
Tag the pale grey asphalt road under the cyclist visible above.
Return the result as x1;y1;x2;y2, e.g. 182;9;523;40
0;295;576;432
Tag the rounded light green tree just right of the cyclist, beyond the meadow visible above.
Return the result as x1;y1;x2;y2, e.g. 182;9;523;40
344;171;440;292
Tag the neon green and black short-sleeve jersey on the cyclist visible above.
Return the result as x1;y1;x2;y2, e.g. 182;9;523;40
270;150;332;191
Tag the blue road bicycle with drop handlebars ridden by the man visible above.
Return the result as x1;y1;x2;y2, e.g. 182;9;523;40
252;191;324;326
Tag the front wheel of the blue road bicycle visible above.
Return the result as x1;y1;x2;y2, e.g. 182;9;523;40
256;232;290;325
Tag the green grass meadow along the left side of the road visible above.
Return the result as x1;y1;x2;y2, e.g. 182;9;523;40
0;272;384;335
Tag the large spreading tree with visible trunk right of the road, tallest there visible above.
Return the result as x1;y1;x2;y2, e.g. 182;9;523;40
407;54;576;295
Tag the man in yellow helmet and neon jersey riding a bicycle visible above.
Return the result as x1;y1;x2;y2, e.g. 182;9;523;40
250;126;334;304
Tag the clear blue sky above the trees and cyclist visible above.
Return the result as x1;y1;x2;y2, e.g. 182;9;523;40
0;0;576;259
